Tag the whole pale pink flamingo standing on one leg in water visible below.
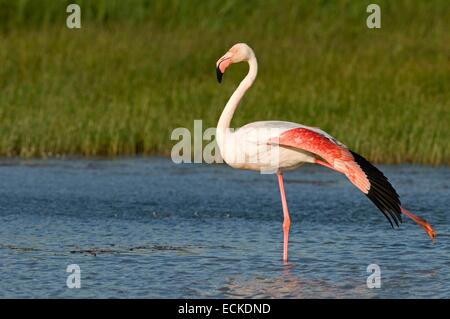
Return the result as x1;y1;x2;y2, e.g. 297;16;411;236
216;43;436;262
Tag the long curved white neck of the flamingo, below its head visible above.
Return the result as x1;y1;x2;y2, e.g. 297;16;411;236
216;56;258;155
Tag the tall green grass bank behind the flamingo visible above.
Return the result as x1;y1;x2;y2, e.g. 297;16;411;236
0;0;450;165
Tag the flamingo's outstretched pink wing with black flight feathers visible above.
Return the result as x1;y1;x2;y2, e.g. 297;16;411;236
269;127;402;227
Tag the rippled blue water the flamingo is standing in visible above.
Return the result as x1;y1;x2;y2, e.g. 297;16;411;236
0;158;450;298
